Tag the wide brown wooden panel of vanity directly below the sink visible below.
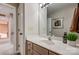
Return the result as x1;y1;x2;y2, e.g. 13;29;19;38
33;44;48;55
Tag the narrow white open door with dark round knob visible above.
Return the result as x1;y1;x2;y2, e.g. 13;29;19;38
18;3;25;55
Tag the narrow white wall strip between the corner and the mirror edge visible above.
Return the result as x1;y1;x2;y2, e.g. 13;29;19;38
39;7;47;36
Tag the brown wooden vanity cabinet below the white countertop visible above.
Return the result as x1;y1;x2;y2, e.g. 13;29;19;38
26;41;60;55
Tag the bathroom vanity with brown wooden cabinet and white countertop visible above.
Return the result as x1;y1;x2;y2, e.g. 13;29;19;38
26;35;79;55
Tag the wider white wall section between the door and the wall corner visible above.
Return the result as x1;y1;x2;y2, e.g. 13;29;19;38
25;3;38;36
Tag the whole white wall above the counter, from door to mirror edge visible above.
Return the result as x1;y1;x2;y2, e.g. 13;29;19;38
25;3;47;36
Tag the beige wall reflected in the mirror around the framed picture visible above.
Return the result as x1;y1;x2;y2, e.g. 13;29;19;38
49;4;77;36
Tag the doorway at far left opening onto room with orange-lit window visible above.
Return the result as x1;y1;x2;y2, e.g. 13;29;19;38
0;3;16;55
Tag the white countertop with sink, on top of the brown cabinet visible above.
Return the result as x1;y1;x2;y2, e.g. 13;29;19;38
26;35;79;55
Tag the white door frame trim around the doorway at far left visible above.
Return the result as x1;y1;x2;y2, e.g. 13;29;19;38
0;3;17;53
